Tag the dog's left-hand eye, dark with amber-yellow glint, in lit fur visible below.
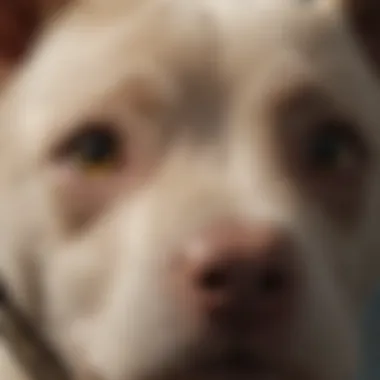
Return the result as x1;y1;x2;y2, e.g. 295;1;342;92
59;123;122;174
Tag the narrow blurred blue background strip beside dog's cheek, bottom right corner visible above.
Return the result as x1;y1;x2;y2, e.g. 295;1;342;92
359;291;380;380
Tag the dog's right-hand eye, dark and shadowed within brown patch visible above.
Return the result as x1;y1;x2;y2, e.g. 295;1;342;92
306;122;361;172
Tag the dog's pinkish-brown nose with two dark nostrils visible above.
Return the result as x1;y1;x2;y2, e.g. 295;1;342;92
186;223;296;331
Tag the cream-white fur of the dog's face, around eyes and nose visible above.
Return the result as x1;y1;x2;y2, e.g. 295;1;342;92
0;0;380;380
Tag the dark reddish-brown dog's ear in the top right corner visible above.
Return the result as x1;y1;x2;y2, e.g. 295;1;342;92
340;0;380;75
